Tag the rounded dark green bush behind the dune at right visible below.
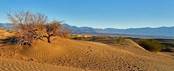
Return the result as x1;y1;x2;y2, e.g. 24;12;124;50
138;39;164;52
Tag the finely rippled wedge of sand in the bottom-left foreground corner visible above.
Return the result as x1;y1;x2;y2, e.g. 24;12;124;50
0;58;92;71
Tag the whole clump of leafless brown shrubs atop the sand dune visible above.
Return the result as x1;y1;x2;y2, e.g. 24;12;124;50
8;11;69;45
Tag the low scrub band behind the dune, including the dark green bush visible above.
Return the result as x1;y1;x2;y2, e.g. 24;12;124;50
72;36;172;52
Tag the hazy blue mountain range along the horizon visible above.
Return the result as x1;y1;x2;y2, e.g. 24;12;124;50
0;23;174;38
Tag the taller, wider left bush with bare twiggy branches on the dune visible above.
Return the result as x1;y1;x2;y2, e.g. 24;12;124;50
8;12;47;45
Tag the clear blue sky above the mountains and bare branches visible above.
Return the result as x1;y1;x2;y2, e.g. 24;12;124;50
0;0;174;28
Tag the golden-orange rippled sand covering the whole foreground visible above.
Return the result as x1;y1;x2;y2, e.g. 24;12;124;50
0;29;174;71
